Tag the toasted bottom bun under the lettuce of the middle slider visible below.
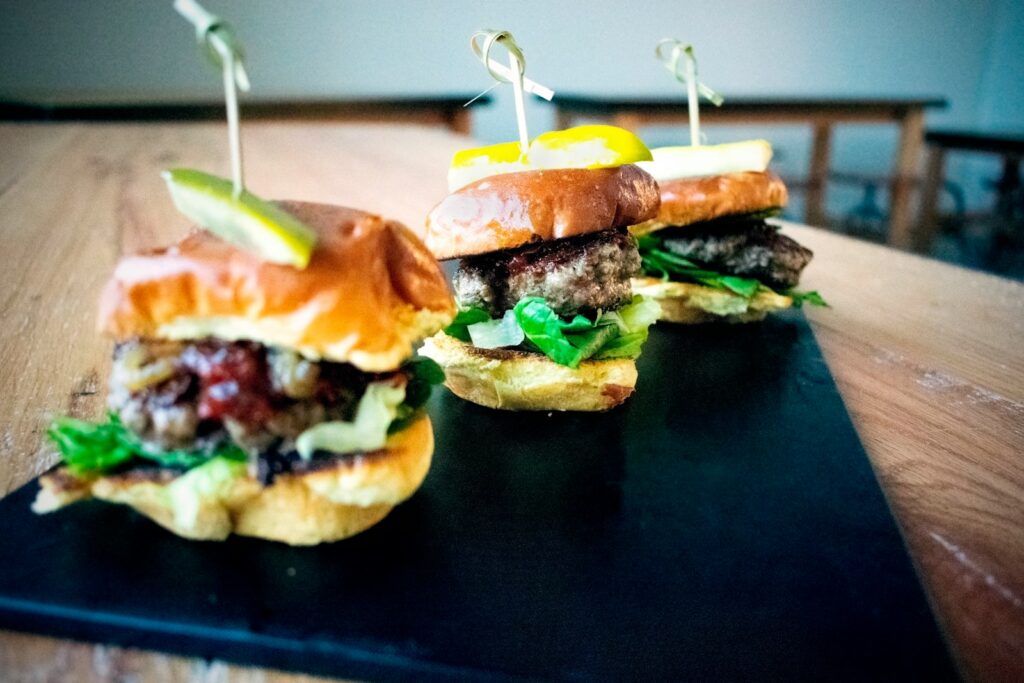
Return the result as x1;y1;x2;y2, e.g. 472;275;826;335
420;332;637;411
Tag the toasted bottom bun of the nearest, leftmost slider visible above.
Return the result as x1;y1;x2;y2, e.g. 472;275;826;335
33;417;434;546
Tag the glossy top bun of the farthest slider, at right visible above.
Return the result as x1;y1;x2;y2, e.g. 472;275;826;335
630;171;788;234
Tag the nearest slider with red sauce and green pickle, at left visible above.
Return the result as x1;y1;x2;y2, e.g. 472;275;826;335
34;171;456;545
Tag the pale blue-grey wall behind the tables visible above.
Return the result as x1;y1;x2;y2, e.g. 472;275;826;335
0;0;1024;216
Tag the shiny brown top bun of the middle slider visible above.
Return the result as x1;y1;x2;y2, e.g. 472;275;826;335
424;164;658;259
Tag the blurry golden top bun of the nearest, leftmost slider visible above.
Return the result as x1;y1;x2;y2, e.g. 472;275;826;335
99;202;456;372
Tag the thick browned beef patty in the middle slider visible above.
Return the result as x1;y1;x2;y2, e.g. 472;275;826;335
453;229;640;317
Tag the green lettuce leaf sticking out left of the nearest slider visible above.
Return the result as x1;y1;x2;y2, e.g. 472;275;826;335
46;413;246;474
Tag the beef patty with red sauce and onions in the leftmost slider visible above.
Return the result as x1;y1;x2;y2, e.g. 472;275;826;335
108;340;406;452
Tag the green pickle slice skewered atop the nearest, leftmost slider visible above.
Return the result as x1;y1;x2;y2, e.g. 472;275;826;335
163;168;316;268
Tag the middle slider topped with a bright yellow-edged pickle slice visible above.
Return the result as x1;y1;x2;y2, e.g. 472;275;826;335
420;126;658;411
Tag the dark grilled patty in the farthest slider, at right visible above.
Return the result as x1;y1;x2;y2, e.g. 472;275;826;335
657;221;814;290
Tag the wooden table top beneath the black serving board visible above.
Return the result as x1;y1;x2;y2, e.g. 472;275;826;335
0;123;1024;681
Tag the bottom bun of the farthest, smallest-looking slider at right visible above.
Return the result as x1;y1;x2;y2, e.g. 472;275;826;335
632;278;793;324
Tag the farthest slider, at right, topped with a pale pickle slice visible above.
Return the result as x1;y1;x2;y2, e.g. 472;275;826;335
631;140;825;323
